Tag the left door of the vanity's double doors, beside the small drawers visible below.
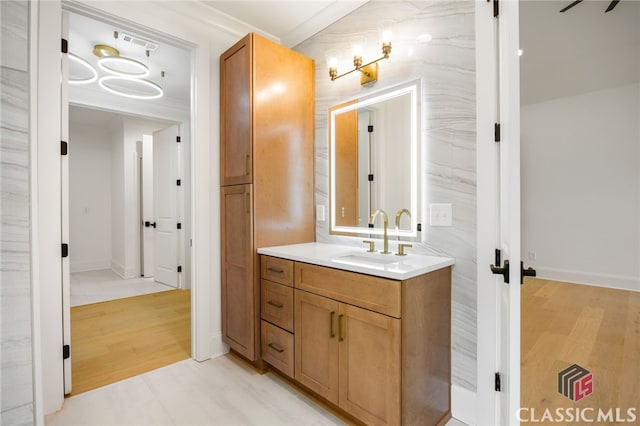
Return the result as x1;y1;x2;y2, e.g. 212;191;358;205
294;290;338;404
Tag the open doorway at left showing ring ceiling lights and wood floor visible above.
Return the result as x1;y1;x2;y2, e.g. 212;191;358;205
63;8;191;394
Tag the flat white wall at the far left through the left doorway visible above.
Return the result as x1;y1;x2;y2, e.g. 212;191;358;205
69;121;112;272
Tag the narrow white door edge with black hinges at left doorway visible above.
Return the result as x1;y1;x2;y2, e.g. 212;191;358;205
60;12;71;395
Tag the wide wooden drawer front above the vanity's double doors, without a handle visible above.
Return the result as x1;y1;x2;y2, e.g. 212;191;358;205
295;262;400;318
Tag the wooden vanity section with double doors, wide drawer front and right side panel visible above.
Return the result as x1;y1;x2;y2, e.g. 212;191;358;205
294;262;451;425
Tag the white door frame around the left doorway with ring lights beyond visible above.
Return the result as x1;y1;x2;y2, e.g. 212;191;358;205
30;1;216;416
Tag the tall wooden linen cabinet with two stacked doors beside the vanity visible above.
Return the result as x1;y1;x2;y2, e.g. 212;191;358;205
220;33;315;361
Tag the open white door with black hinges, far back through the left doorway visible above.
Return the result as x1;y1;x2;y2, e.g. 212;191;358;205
153;125;182;287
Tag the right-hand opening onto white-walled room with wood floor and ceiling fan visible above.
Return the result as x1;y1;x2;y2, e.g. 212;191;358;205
520;1;640;423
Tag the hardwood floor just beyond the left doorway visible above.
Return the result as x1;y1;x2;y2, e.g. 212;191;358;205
71;290;191;395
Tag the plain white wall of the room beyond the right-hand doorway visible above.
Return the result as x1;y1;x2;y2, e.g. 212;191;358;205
521;84;640;291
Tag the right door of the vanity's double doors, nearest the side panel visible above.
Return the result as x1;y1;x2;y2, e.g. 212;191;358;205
338;304;400;425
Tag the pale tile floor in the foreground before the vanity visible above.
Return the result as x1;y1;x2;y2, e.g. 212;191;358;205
46;355;464;426
